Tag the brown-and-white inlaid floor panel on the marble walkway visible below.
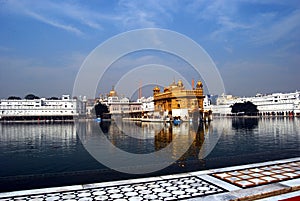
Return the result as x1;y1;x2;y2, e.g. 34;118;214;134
212;161;300;188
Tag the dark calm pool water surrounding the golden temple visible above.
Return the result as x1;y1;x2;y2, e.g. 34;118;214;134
0;117;300;191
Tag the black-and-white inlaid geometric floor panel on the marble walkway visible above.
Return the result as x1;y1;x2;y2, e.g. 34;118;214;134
0;176;226;201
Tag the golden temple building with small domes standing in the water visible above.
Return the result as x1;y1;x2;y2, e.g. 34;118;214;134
153;80;205;120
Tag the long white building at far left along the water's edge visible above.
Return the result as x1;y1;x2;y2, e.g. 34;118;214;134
0;95;86;120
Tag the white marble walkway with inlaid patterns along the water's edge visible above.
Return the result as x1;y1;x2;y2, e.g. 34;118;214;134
0;157;300;201
